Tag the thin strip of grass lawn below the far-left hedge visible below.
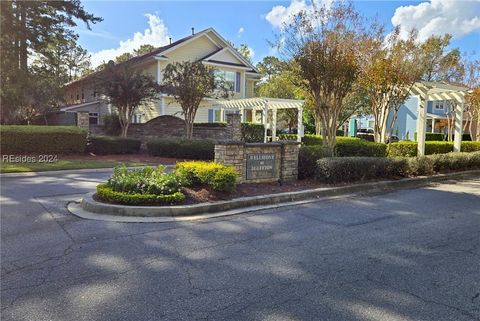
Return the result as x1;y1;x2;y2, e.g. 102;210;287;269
0;159;147;173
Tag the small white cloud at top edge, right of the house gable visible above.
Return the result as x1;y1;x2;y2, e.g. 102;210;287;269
265;0;333;29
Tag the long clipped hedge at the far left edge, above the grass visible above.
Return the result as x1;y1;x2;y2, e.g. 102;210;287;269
0;125;87;155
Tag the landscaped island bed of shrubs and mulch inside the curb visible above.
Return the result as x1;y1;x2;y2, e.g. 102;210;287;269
86;152;480;216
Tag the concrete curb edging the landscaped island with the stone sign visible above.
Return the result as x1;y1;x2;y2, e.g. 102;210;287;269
69;170;480;222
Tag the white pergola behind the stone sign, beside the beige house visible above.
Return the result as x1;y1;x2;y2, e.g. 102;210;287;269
217;97;304;142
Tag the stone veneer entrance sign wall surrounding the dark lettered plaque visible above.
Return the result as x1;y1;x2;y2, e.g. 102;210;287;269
215;141;300;183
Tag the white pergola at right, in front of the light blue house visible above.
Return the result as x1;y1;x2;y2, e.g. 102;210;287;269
412;81;468;156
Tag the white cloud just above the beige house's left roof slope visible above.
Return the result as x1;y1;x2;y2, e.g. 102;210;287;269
92;13;169;67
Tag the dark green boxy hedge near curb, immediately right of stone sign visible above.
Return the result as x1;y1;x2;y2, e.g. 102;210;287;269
315;157;408;183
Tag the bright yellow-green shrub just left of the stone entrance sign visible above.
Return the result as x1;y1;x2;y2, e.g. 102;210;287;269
175;162;238;192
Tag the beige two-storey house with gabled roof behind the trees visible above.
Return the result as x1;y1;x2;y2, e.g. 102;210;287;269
61;28;260;124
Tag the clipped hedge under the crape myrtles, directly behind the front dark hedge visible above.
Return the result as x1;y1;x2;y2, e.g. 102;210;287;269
334;139;387;157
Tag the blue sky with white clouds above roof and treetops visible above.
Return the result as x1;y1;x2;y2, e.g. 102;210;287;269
75;0;480;67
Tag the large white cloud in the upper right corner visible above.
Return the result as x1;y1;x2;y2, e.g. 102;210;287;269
392;0;480;40
